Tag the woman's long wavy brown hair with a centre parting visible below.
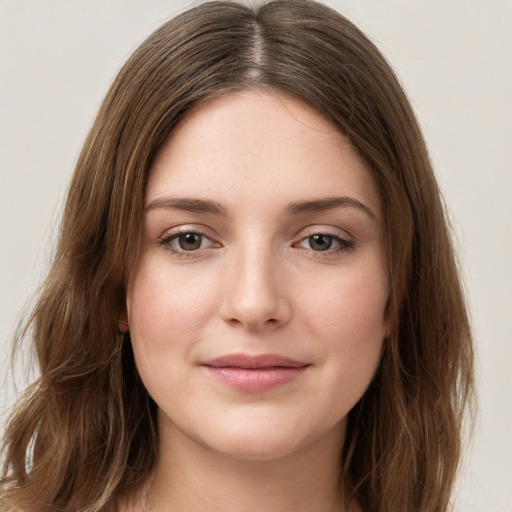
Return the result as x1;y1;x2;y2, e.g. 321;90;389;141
1;0;473;512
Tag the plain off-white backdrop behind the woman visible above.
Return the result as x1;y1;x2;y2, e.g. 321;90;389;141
0;0;512;512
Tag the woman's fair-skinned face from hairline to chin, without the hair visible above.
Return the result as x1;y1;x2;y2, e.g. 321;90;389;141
126;92;388;459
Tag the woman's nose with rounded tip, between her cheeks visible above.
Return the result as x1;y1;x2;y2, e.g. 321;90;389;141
220;248;291;331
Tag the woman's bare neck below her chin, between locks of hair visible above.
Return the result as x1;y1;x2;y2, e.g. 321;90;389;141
138;418;354;512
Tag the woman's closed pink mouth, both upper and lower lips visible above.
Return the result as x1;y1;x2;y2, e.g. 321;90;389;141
201;354;311;393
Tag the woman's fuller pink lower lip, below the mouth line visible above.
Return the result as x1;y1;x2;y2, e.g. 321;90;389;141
204;366;307;393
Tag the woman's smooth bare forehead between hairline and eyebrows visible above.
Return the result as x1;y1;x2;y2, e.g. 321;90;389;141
146;91;380;217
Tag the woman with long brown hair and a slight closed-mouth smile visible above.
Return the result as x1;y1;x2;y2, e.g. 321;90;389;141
2;1;473;512
